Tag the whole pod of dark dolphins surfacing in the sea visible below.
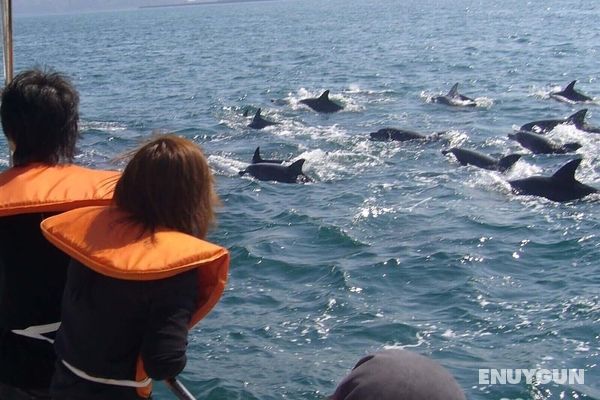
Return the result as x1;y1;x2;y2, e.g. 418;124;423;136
239;81;600;202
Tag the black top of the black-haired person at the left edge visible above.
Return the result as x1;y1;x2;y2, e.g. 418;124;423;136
0;213;69;390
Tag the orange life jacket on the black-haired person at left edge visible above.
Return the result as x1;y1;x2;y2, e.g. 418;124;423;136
0;163;120;217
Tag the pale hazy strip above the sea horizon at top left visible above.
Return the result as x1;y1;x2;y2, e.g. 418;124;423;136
12;0;221;15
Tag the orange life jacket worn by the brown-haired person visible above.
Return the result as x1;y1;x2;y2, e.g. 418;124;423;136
41;207;229;397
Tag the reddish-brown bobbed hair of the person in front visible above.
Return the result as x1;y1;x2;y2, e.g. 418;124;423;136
114;135;219;239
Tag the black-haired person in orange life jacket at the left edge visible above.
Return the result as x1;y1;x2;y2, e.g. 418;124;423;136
0;69;119;399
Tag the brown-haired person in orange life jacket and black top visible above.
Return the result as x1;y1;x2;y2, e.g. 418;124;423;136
42;135;229;400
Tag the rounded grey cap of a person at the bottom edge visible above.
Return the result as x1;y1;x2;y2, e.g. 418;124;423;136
329;349;465;400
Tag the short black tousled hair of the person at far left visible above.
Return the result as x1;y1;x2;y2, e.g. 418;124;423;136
0;69;79;166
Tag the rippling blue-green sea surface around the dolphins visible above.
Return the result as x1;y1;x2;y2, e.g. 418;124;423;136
0;0;600;400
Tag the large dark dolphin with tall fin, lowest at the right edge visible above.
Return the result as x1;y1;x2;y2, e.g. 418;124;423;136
509;158;598;201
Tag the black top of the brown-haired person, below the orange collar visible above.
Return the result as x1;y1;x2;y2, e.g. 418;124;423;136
51;260;198;400
